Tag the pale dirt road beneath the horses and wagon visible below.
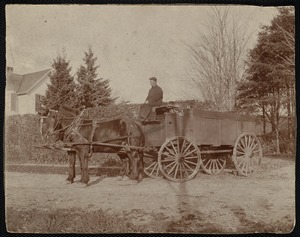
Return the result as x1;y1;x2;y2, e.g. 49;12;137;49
5;158;295;233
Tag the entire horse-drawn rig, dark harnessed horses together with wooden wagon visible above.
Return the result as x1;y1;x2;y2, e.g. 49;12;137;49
39;106;262;183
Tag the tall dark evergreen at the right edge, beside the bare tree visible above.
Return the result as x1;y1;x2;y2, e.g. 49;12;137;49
237;7;295;153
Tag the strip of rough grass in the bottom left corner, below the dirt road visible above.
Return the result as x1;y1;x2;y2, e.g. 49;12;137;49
6;207;141;233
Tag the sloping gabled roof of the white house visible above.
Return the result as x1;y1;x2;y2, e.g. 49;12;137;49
6;69;51;94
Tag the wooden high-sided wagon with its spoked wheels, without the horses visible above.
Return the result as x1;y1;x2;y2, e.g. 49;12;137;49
143;108;262;181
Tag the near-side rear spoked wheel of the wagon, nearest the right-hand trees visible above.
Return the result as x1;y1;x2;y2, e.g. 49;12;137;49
232;133;262;176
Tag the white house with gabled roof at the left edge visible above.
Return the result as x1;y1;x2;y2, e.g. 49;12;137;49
5;67;51;115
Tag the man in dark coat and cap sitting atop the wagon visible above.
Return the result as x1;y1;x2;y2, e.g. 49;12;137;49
139;77;163;122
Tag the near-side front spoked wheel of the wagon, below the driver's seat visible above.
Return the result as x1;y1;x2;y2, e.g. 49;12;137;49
158;137;201;182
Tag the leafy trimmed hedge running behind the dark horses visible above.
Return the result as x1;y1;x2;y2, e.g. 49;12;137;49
4;103;138;165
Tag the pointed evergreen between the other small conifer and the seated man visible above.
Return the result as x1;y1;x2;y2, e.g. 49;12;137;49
76;47;115;107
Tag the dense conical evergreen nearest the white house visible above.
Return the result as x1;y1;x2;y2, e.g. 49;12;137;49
42;55;75;109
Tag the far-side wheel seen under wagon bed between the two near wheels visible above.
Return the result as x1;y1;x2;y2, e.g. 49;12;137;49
201;155;226;174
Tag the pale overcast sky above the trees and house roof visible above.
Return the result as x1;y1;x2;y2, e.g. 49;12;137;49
6;5;277;102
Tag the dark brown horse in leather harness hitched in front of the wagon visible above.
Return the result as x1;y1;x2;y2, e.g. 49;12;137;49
41;106;144;184
